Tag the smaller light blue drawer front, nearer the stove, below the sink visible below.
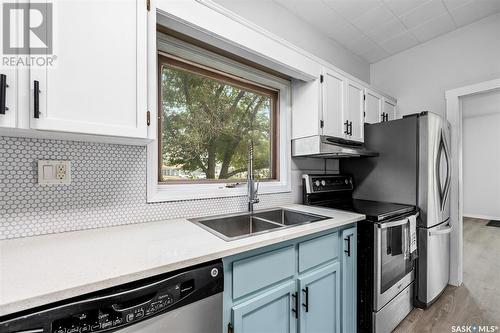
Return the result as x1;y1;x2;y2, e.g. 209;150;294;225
299;232;339;273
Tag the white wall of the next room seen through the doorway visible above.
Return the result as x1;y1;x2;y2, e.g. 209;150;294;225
461;91;500;219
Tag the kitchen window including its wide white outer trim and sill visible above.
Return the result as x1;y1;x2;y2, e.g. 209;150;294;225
148;33;291;202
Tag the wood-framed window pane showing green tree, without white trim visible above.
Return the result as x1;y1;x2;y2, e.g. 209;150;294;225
158;55;279;184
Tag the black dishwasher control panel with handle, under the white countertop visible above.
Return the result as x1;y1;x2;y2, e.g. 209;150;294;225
0;261;224;333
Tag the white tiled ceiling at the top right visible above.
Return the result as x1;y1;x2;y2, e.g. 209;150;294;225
268;0;500;63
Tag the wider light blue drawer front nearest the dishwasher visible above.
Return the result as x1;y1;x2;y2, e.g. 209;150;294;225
233;246;296;299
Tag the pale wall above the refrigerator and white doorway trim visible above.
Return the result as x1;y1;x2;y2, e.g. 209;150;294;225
371;14;500;115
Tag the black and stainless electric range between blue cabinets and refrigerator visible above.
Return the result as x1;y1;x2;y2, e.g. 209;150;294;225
302;174;419;333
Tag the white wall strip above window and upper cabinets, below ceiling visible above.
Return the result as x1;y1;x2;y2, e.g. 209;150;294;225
215;0;370;82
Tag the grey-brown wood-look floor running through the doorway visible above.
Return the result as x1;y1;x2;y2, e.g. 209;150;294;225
393;218;500;333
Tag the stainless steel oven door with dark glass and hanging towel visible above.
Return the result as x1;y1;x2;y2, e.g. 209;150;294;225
373;217;414;311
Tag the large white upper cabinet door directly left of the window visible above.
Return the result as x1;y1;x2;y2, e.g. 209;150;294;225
30;0;147;138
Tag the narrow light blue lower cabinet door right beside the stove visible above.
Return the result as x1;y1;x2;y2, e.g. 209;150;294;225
342;228;357;333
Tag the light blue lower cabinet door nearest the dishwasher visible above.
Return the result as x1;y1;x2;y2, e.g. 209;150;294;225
232;281;297;333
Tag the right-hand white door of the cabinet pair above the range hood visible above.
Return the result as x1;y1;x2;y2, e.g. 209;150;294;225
346;81;364;142
